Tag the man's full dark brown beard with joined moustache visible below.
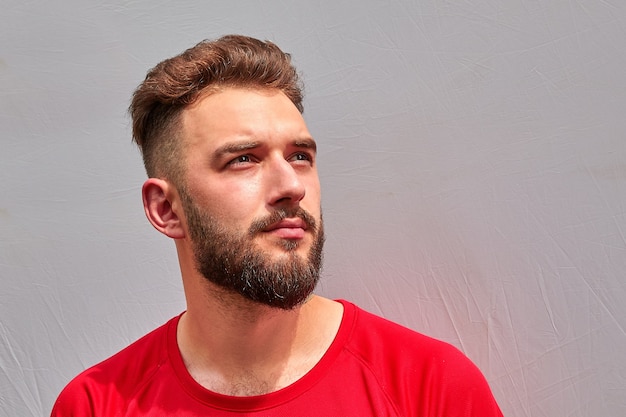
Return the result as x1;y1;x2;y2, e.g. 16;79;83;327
180;191;324;310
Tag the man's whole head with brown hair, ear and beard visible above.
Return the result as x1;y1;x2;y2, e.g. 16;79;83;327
131;36;324;309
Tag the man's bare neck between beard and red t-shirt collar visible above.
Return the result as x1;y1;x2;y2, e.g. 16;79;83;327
178;284;342;396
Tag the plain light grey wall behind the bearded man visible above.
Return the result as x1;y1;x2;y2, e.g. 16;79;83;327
0;0;626;417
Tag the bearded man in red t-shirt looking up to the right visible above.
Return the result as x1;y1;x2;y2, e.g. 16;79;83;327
52;36;502;417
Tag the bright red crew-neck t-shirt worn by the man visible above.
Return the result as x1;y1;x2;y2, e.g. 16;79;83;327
52;301;502;417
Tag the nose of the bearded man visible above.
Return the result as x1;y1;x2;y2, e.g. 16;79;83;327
266;156;306;206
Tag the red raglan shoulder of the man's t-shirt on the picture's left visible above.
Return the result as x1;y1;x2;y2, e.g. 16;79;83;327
52;317;178;417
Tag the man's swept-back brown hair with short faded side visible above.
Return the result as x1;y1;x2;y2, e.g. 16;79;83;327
128;35;303;181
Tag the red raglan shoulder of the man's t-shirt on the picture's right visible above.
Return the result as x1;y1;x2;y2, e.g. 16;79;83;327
336;303;502;416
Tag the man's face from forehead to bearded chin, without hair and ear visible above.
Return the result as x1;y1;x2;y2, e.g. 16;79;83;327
180;88;324;309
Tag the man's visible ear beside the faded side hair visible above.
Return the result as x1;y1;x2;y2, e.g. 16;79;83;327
141;178;185;239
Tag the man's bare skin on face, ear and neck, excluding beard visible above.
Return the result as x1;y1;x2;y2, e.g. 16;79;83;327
143;88;342;395
